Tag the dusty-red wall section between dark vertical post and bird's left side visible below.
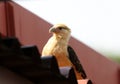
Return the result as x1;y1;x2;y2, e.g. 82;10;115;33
6;2;51;51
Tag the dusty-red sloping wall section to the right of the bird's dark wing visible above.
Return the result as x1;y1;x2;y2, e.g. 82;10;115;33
71;40;120;84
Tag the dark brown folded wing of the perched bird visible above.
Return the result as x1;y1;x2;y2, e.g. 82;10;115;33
68;46;87;78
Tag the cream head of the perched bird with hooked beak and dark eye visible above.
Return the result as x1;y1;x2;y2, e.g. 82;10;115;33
49;24;71;38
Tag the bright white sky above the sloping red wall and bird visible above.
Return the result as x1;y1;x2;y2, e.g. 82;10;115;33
13;0;120;54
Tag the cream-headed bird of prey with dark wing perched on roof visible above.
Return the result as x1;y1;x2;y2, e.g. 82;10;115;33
42;24;86;79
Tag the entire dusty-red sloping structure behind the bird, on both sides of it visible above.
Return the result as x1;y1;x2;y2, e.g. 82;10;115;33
0;1;120;84
